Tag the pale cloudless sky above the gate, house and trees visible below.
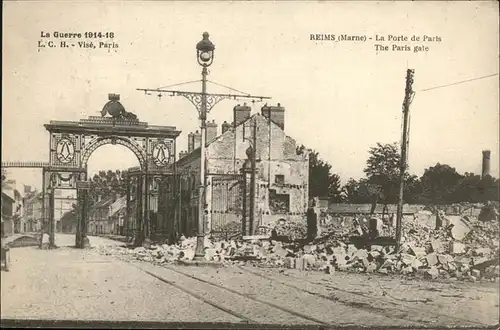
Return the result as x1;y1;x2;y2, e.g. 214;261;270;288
2;1;499;191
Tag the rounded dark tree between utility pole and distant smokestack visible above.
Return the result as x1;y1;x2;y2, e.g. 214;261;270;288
420;163;464;204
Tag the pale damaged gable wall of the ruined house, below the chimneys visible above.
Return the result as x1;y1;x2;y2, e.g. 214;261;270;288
177;114;309;235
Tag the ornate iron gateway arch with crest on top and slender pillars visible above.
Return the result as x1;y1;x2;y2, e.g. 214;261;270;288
42;94;180;248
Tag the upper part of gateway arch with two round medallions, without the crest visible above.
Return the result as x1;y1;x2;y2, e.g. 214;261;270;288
45;116;181;173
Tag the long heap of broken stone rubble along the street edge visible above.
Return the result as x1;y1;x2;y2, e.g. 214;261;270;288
95;213;500;281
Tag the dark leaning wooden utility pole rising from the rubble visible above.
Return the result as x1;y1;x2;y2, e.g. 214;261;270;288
396;69;415;252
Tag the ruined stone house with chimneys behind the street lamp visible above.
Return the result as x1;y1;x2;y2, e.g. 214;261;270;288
176;104;309;236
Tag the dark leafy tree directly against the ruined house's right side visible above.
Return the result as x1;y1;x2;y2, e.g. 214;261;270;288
297;145;342;202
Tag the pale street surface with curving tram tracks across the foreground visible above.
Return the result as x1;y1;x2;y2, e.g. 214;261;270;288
1;234;500;328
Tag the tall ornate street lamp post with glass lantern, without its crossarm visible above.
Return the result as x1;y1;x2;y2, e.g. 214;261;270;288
193;32;215;261
